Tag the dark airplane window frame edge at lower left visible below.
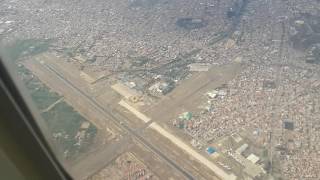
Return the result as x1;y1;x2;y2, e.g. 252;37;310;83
0;58;72;180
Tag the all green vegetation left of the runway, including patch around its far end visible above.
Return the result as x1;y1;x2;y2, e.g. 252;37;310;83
3;39;97;158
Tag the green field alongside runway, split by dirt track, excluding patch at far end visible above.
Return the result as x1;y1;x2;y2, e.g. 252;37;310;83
18;65;97;159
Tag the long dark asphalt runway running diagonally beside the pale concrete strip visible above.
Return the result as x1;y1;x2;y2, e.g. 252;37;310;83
41;63;194;179
